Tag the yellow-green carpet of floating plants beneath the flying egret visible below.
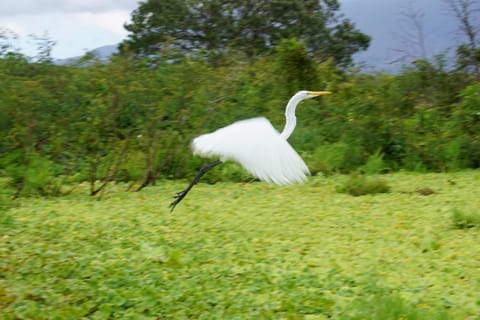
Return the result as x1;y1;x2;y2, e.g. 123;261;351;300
0;171;480;320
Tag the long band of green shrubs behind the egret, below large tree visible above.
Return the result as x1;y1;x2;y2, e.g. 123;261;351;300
0;39;480;196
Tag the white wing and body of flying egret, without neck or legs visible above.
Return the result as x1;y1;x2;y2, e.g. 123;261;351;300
192;118;309;185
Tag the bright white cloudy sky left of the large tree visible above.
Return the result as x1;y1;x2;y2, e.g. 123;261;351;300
0;0;138;58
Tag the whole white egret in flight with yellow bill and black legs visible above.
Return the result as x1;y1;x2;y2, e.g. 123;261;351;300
170;90;330;211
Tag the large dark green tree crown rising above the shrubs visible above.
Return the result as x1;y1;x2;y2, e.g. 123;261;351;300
121;0;370;66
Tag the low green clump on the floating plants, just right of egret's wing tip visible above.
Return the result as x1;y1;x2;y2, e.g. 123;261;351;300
337;174;390;197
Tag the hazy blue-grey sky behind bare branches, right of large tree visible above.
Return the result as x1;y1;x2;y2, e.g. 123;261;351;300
340;0;460;71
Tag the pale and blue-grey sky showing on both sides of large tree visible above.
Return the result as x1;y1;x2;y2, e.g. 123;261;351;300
0;0;462;70
